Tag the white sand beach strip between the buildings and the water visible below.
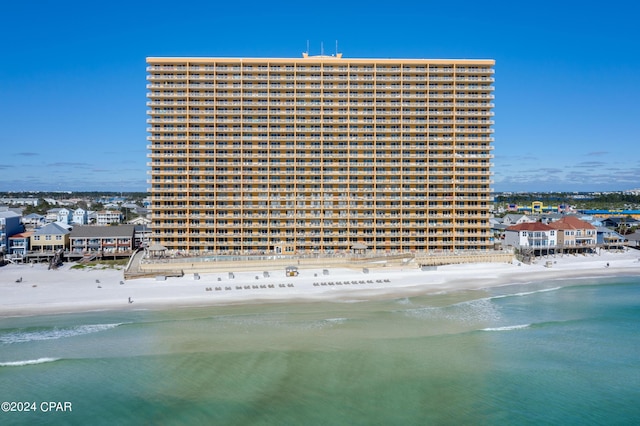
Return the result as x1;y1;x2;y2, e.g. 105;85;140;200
0;250;640;317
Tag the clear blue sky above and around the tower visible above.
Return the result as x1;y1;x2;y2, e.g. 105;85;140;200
0;0;640;191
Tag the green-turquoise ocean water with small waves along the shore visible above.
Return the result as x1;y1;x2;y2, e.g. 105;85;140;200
0;277;640;425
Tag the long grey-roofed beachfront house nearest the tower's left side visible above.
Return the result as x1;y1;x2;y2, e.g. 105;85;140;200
69;225;134;255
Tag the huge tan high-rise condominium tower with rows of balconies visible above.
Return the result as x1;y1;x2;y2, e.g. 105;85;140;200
147;54;494;254
